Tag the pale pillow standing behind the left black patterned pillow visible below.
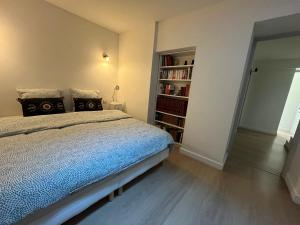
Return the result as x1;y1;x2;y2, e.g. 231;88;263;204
17;89;62;99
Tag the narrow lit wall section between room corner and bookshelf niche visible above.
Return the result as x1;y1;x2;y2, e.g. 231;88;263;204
118;23;155;121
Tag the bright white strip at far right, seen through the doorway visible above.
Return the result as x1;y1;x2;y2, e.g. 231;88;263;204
279;72;300;136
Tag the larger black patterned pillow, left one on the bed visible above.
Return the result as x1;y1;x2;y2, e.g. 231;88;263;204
18;98;66;116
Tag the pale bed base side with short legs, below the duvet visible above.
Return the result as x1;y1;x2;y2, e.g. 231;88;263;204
17;148;169;225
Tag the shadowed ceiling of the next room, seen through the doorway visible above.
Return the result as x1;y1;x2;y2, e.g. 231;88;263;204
254;36;300;60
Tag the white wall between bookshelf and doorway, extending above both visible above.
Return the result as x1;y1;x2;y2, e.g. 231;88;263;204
157;0;300;166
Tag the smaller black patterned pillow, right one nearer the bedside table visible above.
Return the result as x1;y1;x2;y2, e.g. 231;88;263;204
73;98;103;112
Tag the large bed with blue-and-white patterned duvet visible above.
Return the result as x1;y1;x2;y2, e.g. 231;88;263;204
0;110;173;225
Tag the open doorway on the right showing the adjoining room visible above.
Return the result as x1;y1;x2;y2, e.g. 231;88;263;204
229;36;300;176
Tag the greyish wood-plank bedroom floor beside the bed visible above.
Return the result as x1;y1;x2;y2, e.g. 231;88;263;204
65;151;300;225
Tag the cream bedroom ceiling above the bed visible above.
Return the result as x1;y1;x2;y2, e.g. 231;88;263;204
46;0;222;33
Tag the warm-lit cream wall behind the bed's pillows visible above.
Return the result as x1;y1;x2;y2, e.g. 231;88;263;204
0;0;118;116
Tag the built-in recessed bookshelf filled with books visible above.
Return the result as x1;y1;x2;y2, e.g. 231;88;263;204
154;49;195;144
